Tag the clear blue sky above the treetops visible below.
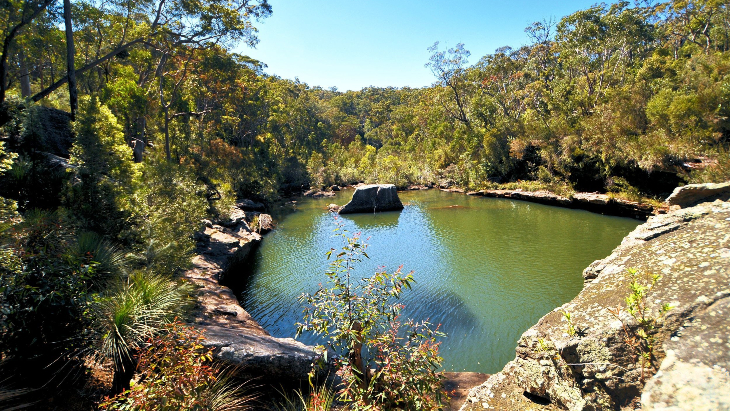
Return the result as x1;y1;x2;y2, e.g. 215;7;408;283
234;0;596;91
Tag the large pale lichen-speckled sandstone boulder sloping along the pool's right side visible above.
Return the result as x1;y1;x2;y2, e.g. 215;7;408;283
462;200;730;410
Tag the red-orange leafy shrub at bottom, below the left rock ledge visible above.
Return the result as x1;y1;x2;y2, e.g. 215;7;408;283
99;322;255;411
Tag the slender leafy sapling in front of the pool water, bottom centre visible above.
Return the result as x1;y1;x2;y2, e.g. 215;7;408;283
298;227;443;410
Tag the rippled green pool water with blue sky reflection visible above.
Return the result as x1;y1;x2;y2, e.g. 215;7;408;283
239;190;639;373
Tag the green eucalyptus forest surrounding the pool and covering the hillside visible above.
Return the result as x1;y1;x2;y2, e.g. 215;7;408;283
0;0;730;409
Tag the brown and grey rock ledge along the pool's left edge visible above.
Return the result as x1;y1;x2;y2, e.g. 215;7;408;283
183;209;316;384
